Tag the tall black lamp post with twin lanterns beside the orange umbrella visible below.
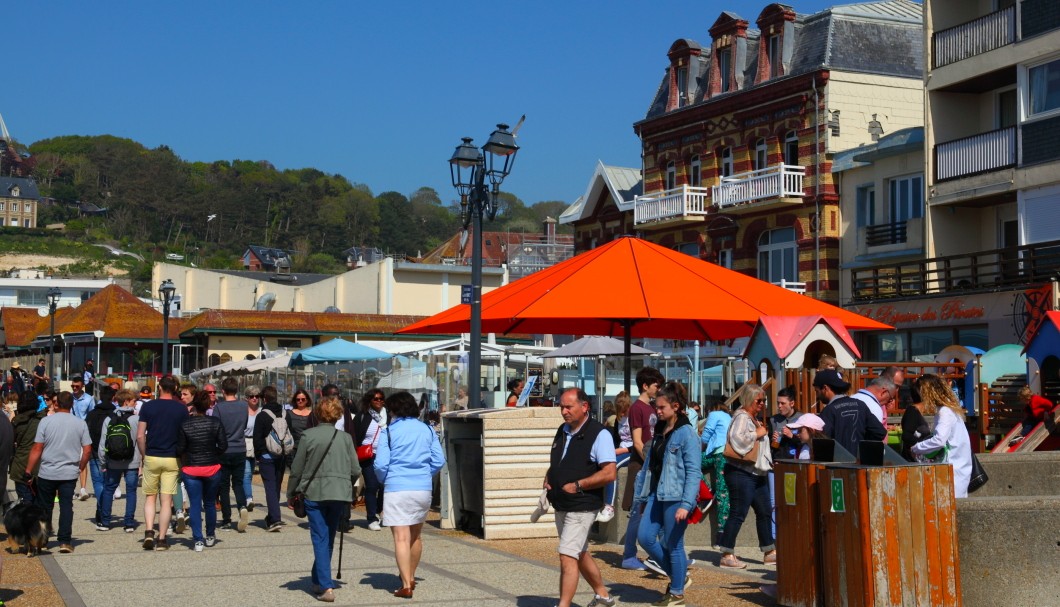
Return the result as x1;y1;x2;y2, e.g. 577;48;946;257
449;124;519;407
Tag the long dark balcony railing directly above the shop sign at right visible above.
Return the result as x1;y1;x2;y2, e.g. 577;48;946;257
850;236;1060;302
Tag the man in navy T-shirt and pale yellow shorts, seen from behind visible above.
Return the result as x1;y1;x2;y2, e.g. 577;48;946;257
136;375;188;550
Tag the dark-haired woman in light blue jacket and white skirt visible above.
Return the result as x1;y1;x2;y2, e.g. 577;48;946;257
375;392;445;599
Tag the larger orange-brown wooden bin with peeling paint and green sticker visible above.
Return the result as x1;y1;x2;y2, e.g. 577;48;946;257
818;464;961;607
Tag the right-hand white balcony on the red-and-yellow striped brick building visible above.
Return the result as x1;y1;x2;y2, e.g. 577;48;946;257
710;164;806;213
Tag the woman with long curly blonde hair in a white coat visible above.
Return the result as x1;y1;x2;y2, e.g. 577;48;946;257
909;375;972;498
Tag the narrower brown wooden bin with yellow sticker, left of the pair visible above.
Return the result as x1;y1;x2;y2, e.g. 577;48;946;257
773;460;825;607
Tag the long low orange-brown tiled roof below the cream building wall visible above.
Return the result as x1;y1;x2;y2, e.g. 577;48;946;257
181;309;425;336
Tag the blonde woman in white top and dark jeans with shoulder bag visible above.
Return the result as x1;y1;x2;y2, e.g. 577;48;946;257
718;383;777;569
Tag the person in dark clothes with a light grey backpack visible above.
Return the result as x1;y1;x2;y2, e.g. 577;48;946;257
253;386;295;532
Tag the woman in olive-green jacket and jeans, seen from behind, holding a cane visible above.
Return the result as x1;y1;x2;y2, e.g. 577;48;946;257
287;396;360;603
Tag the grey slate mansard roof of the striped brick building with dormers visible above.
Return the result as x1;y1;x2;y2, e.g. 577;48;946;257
646;0;924;119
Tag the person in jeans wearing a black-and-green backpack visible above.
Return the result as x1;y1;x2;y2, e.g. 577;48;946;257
95;390;140;533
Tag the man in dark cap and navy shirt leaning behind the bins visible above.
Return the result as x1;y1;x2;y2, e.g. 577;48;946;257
813;369;887;458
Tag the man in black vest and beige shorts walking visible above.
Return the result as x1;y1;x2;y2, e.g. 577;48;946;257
544;388;616;607
